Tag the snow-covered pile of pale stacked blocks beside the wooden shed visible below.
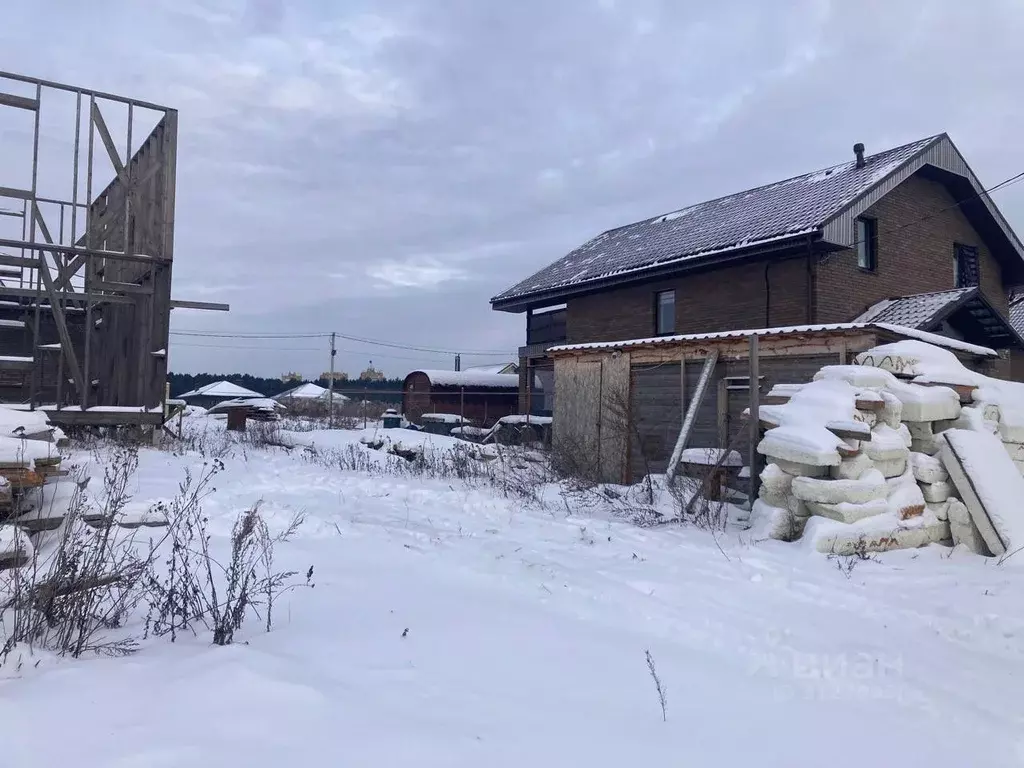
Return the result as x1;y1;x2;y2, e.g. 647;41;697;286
754;341;1024;554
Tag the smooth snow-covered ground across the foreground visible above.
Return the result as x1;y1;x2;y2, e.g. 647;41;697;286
0;427;1024;768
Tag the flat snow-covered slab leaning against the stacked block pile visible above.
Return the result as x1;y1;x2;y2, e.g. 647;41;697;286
940;429;1024;556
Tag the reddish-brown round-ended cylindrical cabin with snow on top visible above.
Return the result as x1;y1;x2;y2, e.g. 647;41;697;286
401;370;519;426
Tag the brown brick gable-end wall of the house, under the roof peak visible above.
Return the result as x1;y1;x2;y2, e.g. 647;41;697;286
816;176;1007;323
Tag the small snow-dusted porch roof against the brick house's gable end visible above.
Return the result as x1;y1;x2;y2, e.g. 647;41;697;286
854;286;1024;349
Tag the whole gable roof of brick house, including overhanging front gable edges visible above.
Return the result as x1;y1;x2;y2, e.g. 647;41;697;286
490;134;1024;311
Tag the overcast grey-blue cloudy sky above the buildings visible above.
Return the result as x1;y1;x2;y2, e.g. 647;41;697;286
0;0;1024;376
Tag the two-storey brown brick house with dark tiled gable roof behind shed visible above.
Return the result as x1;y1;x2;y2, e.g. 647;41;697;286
490;134;1024;413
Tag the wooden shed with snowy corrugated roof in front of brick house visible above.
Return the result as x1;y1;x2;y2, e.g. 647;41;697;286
549;323;999;482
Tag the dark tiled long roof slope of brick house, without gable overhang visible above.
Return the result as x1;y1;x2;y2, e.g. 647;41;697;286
492;135;945;304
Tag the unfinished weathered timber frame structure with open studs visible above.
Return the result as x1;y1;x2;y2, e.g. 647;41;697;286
0;72;227;425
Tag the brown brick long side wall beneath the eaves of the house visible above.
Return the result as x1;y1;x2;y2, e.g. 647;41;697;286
566;256;808;344
